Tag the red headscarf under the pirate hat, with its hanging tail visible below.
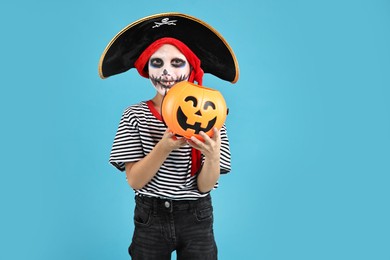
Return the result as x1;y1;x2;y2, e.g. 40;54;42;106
134;37;204;176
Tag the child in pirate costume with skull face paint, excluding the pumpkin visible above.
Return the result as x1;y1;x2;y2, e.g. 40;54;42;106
99;13;238;260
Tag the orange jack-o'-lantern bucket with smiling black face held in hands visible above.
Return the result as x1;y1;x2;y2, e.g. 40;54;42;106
162;81;227;139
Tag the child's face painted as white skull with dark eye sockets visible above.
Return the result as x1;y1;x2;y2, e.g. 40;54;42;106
148;44;191;96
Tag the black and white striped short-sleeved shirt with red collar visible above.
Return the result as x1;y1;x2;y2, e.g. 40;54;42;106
110;101;230;200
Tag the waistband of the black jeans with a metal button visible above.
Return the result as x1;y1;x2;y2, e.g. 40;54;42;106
135;194;211;212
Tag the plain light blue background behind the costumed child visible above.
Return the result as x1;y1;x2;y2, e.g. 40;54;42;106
0;0;390;260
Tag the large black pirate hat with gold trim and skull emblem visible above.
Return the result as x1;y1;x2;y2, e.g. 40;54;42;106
98;13;239;83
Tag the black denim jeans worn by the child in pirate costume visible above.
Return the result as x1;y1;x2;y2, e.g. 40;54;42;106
129;195;217;260
